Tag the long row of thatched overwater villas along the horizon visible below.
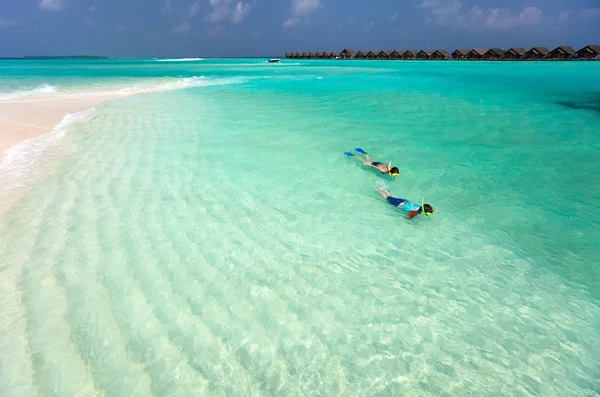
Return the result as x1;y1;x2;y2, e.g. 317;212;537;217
285;44;600;61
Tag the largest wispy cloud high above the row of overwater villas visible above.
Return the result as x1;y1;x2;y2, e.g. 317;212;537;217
417;0;543;29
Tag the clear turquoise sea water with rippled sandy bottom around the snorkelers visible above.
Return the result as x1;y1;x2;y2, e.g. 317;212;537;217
0;59;600;396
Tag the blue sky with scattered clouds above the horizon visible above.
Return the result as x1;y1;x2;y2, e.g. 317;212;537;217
0;0;600;57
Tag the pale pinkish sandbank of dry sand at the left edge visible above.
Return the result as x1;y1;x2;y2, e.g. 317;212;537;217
0;93;130;163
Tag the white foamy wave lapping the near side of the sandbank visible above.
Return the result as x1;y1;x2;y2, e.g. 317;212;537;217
0;108;95;190
